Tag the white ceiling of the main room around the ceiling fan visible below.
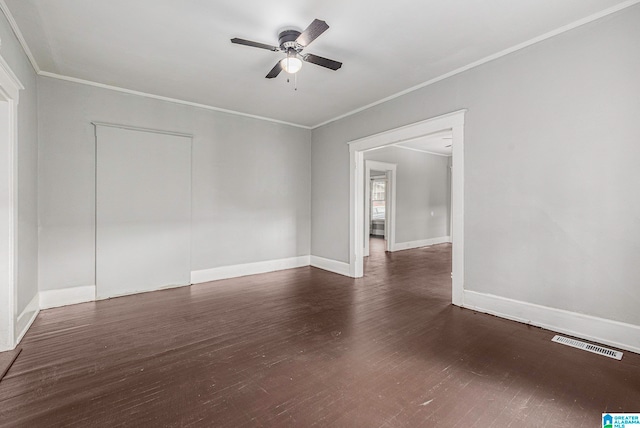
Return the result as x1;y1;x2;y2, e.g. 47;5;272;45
0;0;637;127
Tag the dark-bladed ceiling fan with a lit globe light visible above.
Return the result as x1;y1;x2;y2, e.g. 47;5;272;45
231;19;342;79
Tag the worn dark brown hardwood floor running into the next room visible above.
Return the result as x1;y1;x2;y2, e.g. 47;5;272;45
0;240;640;427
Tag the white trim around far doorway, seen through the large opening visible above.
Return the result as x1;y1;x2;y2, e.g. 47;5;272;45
363;160;397;257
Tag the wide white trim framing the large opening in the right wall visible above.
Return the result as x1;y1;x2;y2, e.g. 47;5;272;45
349;109;466;306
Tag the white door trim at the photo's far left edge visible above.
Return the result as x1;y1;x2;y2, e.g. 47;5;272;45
0;52;24;351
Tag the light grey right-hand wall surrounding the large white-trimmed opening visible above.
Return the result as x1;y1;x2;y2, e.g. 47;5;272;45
311;6;640;326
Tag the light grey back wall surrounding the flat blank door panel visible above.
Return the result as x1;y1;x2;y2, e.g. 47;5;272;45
38;77;311;290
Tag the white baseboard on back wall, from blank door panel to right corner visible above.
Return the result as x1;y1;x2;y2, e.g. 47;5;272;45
191;256;310;284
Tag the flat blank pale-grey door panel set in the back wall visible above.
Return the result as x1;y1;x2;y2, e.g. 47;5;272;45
96;125;191;299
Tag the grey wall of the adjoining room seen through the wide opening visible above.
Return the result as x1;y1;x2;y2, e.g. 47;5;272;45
364;147;451;244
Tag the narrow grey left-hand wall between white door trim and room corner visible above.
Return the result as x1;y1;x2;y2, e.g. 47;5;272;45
0;13;38;322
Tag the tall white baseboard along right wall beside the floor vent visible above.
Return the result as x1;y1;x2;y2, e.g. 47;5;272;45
463;290;640;354
